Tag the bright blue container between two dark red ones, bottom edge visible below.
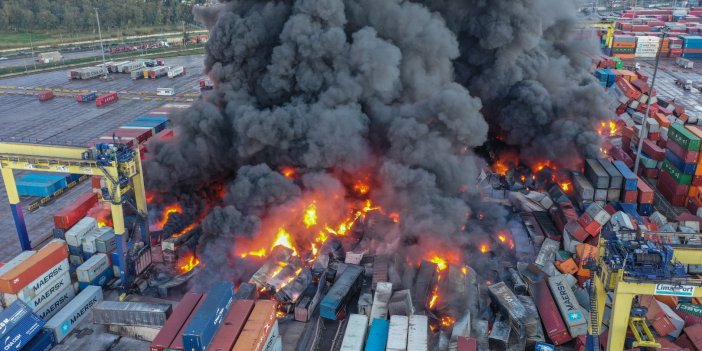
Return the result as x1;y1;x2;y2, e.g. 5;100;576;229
183;281;234;351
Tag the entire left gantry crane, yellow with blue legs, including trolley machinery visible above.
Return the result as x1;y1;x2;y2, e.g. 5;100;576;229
0;142;148;289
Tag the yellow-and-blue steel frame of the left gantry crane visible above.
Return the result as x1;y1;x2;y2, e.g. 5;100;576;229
0;142;147;286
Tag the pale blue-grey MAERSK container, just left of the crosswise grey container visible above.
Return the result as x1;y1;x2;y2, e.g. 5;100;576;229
44;286;102;342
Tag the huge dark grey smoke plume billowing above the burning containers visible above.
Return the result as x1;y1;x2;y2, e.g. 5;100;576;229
145;0;609;284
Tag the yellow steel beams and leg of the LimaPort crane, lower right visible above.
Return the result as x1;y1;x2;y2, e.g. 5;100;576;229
591;233;702;351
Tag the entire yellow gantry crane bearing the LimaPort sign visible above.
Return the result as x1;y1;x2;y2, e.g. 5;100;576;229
590;232;702;351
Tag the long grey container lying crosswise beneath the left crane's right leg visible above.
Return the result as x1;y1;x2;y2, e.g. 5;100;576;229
93;301;173;327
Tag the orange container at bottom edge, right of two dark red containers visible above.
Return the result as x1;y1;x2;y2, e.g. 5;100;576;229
232;300;280;351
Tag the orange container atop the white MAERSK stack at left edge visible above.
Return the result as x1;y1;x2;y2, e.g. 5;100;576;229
0;241;68;294
